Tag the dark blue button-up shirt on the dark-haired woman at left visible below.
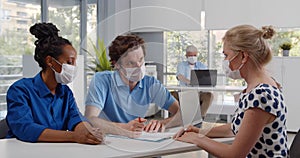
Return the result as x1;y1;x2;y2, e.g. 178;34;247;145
6;73;84;142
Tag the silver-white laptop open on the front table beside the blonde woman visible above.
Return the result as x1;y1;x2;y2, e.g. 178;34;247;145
178;90;203;128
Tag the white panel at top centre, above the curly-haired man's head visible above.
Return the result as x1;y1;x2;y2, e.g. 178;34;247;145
130;0;202;32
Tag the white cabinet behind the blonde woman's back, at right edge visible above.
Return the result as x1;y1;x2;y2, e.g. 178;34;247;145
267;57;300;132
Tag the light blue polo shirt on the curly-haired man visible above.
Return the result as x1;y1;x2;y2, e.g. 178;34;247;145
85;71;175;123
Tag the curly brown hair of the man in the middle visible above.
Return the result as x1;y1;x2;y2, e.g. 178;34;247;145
109;34;145;66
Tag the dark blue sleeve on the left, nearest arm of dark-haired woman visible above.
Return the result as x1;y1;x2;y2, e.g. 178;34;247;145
6;85;46;142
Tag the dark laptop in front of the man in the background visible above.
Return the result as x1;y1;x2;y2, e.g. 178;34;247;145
190;69;217;87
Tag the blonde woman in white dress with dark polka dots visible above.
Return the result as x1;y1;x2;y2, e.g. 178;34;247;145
174;25;288;158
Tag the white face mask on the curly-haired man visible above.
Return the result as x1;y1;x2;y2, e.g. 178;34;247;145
123;64;146;82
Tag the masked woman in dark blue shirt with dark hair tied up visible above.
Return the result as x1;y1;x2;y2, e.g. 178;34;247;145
6;23;103;144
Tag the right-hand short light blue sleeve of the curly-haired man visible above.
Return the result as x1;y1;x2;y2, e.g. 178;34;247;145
150;80;175;110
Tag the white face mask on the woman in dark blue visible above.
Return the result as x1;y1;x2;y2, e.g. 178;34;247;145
51;58;77;84
